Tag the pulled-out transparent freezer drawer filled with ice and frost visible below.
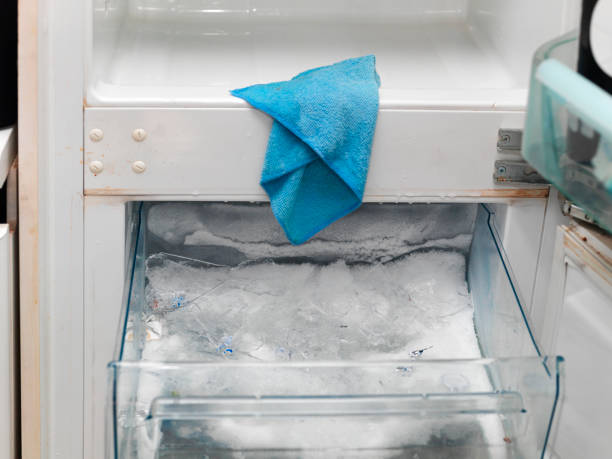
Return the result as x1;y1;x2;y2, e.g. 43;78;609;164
107;203;562;459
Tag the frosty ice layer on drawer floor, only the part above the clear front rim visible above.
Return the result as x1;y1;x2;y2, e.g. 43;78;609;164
142;251;480;362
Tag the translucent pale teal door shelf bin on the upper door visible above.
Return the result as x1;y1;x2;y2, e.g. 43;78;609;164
523;34;612;231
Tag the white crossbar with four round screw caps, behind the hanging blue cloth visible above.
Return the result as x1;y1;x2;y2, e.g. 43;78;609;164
85;108;548;201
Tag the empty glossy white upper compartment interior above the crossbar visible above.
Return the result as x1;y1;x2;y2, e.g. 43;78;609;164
87;0;577;108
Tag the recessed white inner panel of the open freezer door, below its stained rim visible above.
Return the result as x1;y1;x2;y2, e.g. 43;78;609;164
554;263;612;459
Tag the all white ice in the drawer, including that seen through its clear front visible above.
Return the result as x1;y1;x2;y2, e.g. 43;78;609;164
129;250;504;458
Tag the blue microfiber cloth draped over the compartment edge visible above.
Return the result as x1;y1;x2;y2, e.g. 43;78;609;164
231;55;380;244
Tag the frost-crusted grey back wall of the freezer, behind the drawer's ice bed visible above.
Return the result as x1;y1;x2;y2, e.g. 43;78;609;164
147;203;477;266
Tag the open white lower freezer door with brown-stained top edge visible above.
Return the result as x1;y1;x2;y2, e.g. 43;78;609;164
539;223;612;459
